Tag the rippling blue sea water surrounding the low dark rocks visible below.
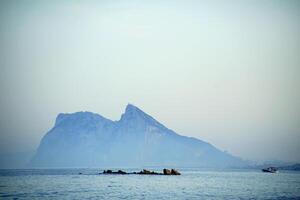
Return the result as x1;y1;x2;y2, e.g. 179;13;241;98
0;169;300;199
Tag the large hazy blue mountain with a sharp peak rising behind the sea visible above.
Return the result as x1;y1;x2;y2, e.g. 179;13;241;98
29;104;246;168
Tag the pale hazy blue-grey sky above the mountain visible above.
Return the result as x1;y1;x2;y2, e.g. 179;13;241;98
0;0;300;162
